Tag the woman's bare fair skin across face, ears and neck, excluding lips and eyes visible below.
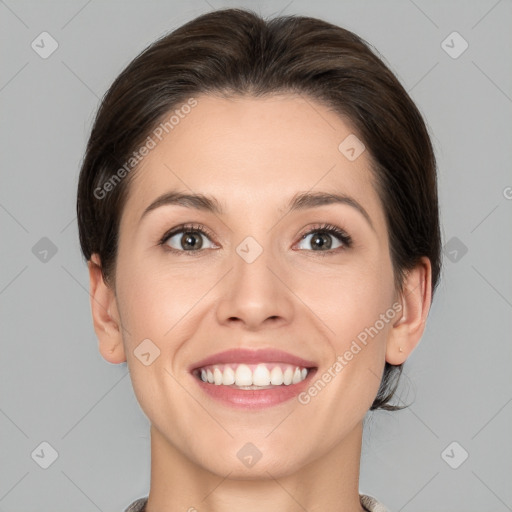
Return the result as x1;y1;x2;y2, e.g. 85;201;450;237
89;94;431;512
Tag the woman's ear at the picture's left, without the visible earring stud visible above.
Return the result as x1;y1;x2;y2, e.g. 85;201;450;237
87;254;126;364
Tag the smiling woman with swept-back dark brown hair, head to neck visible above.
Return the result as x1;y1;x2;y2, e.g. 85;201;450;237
77;9;440;512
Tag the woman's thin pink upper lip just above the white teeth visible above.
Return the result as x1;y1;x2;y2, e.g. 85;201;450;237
189;348;316;371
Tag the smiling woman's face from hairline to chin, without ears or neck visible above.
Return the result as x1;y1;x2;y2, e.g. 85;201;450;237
108;95;398;479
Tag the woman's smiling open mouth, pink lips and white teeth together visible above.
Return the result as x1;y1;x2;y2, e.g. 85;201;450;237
190;349;317;409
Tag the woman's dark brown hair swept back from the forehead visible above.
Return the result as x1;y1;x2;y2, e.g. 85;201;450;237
77;9;441;410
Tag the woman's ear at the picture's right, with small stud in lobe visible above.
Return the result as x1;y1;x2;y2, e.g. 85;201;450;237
386;256;432;365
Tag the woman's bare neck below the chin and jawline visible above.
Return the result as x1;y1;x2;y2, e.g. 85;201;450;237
146;423;364;512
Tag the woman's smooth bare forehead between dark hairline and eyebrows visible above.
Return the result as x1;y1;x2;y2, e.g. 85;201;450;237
123;94;383;232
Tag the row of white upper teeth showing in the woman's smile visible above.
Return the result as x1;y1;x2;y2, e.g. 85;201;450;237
200;363;308;386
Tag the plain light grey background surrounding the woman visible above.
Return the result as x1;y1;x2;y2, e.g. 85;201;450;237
0;0;512;512
